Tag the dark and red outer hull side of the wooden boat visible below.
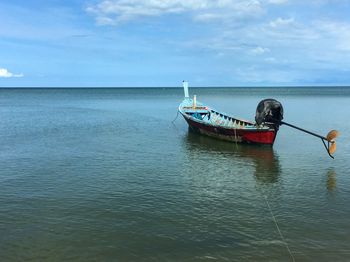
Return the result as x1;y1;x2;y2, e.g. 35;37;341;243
182;114;277;145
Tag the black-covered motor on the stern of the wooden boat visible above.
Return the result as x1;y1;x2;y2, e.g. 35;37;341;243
255;98;283;129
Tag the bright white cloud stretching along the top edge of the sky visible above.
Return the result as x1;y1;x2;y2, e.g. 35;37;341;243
86;0;263;25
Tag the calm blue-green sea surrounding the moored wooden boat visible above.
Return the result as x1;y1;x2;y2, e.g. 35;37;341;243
0;87;350;262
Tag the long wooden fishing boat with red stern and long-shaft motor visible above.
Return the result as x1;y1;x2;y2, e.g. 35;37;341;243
178;81;338;158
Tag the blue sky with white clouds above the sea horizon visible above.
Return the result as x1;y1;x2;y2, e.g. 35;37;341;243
0;0;350;87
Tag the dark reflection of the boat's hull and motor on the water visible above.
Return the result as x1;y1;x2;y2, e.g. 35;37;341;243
185;129;281;183
